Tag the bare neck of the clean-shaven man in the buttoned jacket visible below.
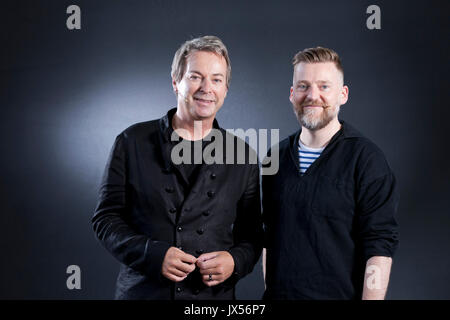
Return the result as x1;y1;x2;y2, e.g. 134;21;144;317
172;109;214;140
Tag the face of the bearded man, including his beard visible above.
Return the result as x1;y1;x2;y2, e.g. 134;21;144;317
289;62;348;130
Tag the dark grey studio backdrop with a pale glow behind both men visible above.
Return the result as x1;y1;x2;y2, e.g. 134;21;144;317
0;0;450;299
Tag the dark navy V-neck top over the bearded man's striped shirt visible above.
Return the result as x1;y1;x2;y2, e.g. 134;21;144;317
262;122;398;300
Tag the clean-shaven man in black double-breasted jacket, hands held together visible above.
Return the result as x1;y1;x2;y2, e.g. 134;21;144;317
92;36;263;300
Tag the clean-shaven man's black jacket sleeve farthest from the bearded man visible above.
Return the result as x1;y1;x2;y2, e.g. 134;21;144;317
91;133;170;279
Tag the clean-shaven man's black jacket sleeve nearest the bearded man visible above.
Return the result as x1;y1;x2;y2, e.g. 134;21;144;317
229;160;263;281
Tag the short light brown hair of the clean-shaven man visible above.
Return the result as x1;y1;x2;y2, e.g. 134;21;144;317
171;36;231;87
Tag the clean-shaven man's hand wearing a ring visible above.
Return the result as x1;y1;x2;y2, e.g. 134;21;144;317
197;251;234;287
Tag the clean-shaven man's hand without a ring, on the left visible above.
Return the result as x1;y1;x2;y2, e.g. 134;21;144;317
161;247;197;282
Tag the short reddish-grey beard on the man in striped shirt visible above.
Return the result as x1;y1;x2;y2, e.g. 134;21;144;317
294;102;340;130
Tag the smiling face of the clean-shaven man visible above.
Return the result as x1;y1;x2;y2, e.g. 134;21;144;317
172;51;228;120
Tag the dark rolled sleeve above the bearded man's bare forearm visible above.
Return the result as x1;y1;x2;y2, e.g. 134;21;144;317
357;148;399;263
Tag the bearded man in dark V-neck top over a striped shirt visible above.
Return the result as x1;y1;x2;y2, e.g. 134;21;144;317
262;47;398;300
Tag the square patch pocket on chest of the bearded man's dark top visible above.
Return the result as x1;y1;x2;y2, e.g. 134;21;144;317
310;175;355;222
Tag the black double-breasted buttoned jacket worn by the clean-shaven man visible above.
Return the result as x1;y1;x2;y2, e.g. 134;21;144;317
92;109;262;299
